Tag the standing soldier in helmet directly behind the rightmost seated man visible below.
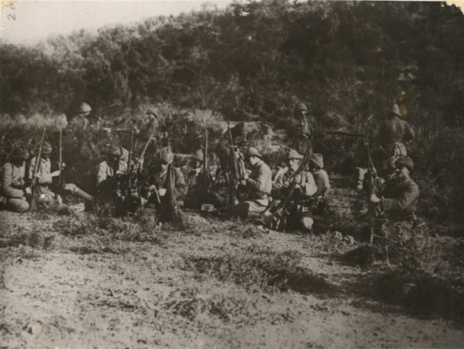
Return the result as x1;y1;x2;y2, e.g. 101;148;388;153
377;103;415;171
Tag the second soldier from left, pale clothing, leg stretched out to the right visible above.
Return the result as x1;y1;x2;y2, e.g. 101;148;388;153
29;142;94;204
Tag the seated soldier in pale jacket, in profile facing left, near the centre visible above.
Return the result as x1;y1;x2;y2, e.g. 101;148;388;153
224;147;272;218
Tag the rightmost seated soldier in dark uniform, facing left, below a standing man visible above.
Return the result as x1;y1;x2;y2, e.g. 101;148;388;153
370;156;419;220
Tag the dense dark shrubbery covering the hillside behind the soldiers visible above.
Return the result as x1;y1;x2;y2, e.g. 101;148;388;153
0;0;464;220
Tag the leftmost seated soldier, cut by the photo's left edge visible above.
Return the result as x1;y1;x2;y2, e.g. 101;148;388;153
0;146;31;212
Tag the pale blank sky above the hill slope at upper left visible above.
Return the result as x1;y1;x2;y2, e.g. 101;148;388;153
0;0;232;45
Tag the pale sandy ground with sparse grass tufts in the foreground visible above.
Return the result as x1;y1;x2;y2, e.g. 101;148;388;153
0;212;464;349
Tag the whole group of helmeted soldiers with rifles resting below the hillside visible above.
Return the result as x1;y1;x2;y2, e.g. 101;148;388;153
0;95;419;231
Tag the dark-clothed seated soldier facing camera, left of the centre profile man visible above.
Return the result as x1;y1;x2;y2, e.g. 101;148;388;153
142;147;187;223
